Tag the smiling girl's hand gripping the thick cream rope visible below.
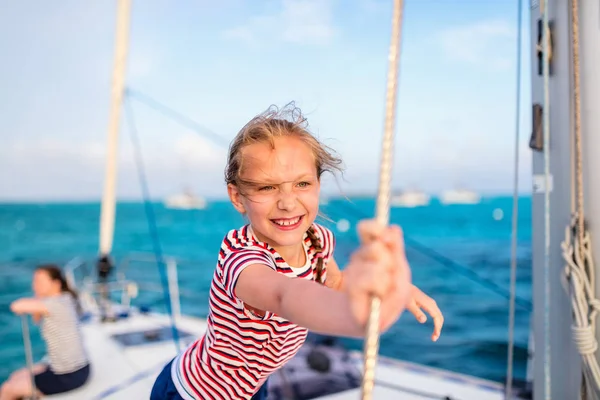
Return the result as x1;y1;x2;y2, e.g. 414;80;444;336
344;220;412;331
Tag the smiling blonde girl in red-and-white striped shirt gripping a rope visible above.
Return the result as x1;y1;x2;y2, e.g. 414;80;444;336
151;105;442;400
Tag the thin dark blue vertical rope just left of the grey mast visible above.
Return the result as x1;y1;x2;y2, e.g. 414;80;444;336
505;0;523;399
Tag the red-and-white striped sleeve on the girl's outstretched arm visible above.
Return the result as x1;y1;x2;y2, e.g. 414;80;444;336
222;248;276;300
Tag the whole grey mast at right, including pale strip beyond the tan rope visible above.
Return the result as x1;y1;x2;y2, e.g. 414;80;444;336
530;0;600;400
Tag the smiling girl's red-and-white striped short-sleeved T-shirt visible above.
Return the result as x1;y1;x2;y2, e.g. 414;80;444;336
171;224;335;400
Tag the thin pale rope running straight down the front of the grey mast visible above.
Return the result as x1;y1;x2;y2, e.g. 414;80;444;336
540;0;551;400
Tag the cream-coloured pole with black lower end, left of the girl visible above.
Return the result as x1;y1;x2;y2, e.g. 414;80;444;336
97;0;131;316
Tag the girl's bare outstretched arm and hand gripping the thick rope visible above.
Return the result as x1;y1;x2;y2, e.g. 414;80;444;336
234;221;410;337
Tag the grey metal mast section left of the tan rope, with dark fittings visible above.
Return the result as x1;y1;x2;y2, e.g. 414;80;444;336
531;0;581;400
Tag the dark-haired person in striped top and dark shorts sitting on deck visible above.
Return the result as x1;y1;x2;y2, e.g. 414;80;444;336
0;265;90;400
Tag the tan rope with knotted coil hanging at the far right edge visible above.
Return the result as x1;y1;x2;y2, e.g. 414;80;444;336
561;0;600;398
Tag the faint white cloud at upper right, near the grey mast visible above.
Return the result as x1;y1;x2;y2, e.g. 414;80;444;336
435;20;516;69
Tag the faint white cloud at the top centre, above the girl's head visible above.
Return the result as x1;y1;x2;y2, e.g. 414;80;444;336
223;0;337;45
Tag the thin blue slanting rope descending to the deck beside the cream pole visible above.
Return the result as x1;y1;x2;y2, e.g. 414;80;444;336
123;98;180;353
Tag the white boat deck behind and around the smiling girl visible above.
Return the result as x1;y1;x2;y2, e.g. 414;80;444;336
47;311;520;400
